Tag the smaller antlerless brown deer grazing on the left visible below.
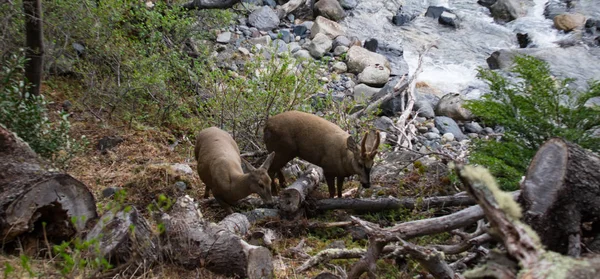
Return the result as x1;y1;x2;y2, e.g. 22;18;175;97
194;127;275;214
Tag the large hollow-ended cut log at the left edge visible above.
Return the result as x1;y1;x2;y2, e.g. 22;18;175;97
0;125;98;247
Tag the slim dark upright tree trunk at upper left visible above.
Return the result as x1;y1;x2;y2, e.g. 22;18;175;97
23;0;44;96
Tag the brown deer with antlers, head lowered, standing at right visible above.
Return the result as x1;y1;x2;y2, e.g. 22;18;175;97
264;111;379;198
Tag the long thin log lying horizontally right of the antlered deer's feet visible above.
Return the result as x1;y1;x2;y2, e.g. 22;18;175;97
315;196;475;212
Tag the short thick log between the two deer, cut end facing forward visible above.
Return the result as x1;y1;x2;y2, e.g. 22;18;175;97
279;165;323;214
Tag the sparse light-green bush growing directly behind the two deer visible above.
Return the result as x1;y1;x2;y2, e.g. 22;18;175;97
198;49;320;151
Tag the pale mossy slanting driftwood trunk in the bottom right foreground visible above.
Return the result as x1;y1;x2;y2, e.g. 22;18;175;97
456;166;600;279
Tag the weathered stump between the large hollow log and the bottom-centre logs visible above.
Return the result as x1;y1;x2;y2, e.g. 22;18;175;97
85;207;159;270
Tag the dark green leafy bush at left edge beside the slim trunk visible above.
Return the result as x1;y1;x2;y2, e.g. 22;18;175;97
0;51;81;160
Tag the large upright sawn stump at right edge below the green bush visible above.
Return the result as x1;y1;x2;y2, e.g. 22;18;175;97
520;138;600;256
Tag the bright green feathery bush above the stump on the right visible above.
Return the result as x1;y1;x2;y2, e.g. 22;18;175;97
467;56;600;189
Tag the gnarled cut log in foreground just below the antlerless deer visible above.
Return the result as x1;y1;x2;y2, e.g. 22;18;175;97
161;196;274;278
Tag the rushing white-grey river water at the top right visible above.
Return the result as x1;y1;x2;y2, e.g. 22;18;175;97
342;0;600;98
